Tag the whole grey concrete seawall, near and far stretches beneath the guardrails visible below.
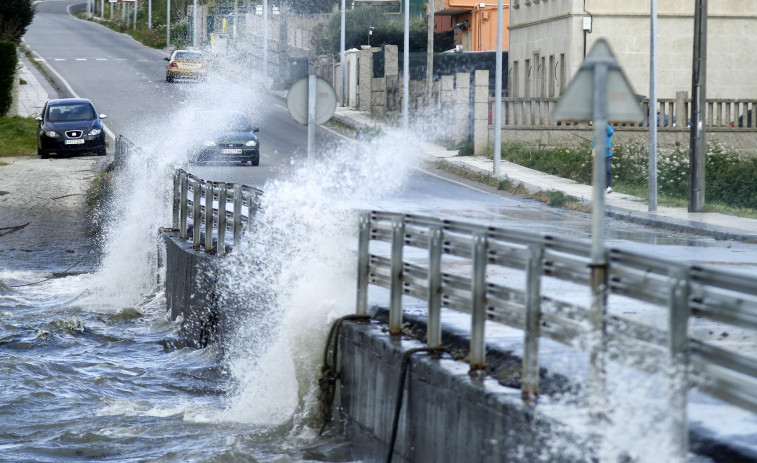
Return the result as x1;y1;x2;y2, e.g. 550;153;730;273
162;231;757;463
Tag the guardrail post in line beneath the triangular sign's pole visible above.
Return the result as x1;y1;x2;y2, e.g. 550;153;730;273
588;253;608;422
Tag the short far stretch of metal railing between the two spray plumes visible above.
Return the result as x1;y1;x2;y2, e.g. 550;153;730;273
173;169;263;256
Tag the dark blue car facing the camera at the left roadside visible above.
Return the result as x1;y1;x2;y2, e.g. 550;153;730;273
37;98;108;159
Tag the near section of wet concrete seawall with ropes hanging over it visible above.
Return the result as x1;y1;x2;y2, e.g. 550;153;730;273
337;321;590;463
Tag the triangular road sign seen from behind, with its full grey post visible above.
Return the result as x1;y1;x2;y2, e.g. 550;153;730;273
553;39;644;430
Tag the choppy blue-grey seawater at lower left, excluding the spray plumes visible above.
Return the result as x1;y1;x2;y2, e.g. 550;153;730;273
0;271;349;462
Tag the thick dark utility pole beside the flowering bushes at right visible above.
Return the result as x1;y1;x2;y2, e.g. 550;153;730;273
681;0;707;212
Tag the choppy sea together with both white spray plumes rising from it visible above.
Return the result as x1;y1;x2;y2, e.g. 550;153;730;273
0;89;426;462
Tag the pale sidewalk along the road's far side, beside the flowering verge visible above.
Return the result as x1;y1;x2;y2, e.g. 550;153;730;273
334;106;757;242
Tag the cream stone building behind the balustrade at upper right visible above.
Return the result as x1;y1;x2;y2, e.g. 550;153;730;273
509;0;757;100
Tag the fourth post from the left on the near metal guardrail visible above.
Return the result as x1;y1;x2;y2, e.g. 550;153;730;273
469;232;487;373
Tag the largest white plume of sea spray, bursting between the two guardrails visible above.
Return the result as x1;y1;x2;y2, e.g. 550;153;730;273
219;129;420;424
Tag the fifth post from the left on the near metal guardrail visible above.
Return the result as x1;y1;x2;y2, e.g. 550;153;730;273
521;245;544;403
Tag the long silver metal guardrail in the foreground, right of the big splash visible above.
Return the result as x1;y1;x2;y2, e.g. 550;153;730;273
357;211;757;455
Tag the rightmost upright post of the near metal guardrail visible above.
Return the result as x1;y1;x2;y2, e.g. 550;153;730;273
668;267;689;461
